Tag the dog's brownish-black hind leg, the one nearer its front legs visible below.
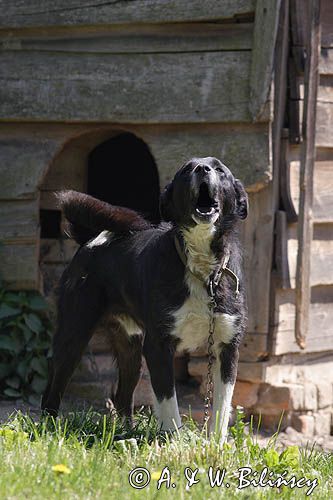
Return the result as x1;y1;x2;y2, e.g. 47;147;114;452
113;329;142;420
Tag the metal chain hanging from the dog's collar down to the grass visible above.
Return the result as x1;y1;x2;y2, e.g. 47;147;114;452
204;279;216;425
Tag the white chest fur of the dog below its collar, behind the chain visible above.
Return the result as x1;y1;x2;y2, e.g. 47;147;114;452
171;276;236;351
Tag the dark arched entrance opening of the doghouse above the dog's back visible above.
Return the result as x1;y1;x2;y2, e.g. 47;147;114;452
87;133;160;223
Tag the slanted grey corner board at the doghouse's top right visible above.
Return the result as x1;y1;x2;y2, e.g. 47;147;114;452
250;0;281;121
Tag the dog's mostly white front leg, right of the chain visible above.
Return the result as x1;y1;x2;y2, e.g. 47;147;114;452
210;344;238;444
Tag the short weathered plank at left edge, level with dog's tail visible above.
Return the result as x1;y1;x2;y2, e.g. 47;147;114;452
0;199;39;243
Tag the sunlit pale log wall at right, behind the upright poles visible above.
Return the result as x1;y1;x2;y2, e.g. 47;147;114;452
272;0;333;355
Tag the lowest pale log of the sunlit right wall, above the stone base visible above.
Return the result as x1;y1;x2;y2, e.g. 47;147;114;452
272;286;333;355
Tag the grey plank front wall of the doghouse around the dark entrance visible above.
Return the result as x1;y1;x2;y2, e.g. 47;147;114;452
0;0;280;372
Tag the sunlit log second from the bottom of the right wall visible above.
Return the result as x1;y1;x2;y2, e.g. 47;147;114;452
286;222;333;288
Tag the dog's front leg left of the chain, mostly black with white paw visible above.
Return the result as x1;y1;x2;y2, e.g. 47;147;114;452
144;340;181;431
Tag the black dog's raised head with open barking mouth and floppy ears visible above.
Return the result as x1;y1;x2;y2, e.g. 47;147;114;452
160;156;248;227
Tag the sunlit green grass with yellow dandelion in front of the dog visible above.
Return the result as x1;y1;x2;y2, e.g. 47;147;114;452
0;411;333;500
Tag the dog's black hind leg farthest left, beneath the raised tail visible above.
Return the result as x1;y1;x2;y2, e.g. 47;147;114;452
41;277;105;416
